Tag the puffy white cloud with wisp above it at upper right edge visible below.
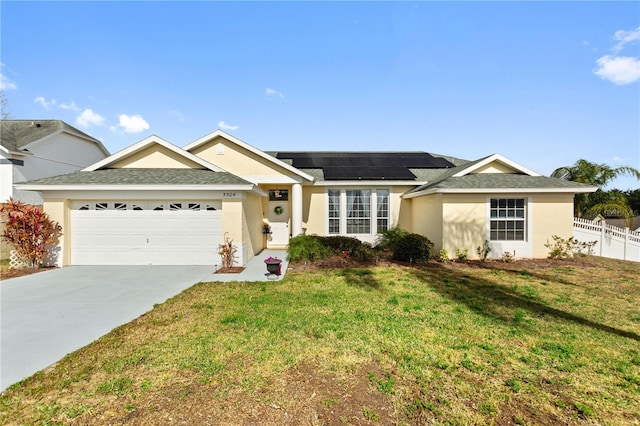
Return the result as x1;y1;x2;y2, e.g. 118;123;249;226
593;27;640;85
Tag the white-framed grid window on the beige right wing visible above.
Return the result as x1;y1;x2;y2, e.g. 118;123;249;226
489;198;527;241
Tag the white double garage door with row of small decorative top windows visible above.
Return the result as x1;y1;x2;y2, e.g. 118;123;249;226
71;201;222;265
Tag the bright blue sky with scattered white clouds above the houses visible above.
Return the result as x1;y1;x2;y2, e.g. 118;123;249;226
0;1;640;189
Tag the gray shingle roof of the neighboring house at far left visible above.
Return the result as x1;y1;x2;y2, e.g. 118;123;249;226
0;120;109;155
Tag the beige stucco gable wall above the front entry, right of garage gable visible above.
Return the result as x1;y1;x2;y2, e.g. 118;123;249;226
190;137;293;176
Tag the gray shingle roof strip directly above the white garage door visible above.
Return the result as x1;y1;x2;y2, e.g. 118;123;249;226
23;169;251;185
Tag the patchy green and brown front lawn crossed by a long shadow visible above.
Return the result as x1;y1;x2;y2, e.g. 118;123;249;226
0;258;640;425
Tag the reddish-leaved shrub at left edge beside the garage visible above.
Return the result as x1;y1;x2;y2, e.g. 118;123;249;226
0;198;62;267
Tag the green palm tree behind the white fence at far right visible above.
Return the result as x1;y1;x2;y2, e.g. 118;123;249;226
551;160;640;226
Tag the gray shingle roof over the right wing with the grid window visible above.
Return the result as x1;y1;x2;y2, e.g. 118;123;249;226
409;172;591;193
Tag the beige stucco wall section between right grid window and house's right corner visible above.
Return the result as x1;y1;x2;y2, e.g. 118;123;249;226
530;194;573;258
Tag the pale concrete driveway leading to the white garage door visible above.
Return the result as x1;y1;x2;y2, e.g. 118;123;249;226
0;266;214;391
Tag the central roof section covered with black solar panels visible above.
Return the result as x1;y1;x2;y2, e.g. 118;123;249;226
269;151;465;182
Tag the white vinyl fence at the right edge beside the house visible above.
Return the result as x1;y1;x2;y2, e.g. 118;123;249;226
573;218;640;262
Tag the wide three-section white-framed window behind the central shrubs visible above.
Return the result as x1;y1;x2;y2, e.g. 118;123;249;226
327;188;391;235
